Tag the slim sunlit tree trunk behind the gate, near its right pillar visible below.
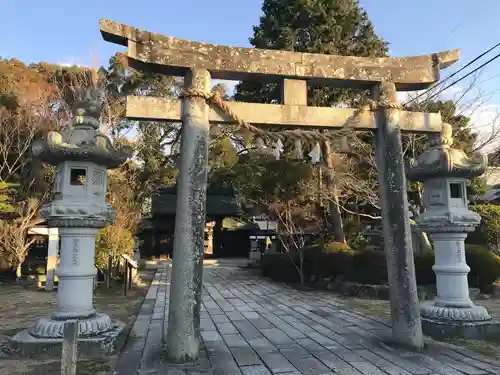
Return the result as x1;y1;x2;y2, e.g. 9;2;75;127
323;141;346;243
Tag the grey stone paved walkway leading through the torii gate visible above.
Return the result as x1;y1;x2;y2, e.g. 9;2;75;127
115;267;500;375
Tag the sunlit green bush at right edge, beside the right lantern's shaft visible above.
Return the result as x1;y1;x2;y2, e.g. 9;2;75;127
467;204;500;254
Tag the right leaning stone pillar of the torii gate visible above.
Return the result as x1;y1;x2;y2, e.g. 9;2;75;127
373;83;424;349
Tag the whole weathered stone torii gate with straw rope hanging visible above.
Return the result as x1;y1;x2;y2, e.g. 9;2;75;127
100;20;459;361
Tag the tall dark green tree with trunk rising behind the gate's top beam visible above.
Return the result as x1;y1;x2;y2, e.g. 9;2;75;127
235;0;388;242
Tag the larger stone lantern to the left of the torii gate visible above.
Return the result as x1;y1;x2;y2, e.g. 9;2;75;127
12;93;131;349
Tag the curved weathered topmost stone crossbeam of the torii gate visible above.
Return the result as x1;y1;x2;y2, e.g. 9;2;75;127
100;19;460;91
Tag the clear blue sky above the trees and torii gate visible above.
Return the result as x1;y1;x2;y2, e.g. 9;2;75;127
0;0;500;145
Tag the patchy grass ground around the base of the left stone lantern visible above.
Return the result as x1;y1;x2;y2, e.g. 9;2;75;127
0;270;155;375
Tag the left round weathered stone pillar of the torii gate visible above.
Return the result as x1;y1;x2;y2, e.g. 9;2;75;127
167;69;210;362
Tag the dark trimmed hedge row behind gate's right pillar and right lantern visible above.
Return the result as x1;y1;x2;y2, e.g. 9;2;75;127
261;245;500;292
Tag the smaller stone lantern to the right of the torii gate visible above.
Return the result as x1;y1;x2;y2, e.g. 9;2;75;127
407;124;491;326
